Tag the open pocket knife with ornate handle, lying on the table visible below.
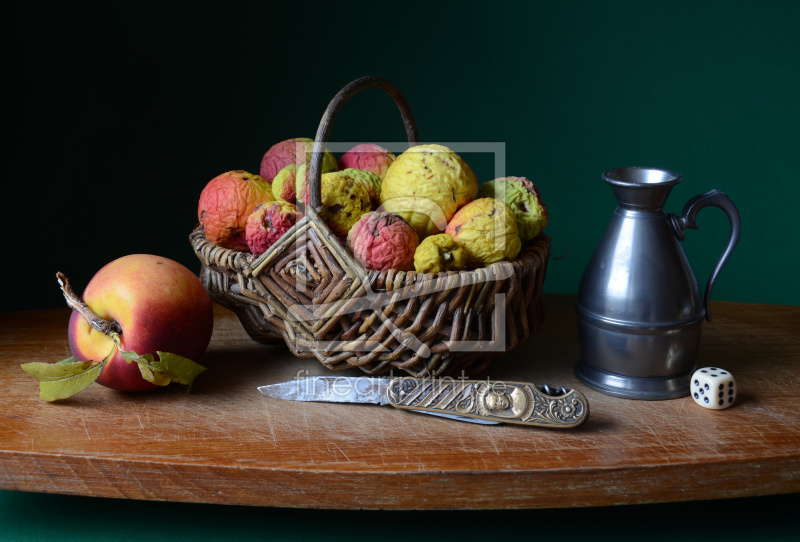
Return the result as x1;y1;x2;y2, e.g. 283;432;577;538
258;376;589;429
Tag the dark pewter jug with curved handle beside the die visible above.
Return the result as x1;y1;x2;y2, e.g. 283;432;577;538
575;167;741;400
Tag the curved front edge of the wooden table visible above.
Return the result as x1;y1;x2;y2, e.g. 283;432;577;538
0;452;800;510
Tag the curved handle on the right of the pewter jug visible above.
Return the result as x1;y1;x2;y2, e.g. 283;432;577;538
669;190;742;322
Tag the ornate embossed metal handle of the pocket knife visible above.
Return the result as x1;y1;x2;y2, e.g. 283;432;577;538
386;377;589;428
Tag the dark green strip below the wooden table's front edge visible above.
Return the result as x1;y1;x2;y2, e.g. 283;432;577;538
0;490;800;542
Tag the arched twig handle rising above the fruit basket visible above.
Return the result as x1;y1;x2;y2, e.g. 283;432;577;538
308;75;418;210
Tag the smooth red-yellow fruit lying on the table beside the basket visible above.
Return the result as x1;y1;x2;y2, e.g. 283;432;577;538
69;254;214;391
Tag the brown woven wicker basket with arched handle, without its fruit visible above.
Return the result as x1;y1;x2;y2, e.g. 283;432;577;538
190;77;550;377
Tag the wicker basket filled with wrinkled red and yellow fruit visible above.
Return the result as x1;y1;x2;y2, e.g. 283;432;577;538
190;76;550;377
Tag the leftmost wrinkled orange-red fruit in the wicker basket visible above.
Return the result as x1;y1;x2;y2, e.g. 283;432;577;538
197;170;275;250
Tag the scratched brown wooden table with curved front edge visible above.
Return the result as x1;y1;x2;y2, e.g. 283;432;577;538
0;296;800;509
